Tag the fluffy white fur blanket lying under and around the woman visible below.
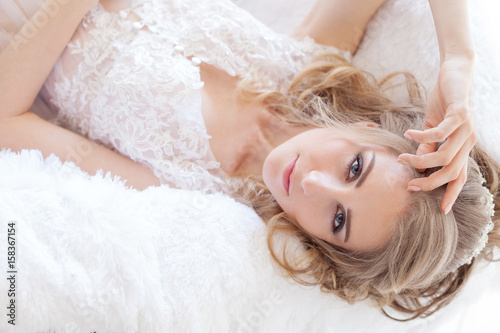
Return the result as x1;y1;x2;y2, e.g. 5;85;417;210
0;0;500;333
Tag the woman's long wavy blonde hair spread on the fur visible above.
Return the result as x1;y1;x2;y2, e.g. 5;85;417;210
233;54;500;320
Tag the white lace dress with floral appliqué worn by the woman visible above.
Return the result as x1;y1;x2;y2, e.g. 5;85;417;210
42;0;346;192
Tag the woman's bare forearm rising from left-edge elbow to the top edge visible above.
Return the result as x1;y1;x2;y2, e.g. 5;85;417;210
0;0;98;119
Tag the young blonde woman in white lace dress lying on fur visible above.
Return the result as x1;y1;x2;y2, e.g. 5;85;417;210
0;0;499;317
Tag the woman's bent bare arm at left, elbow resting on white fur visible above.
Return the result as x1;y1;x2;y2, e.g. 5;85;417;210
0;0;160;189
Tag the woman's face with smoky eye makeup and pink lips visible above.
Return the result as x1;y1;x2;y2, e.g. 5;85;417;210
263;127;410;250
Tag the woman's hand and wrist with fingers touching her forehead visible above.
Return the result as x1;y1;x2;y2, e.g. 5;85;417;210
398;55;476;214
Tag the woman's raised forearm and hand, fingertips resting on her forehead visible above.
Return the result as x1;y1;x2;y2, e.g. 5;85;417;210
400;0;476;213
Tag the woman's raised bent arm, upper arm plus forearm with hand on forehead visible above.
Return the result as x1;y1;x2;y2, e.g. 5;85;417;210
294;0;477;214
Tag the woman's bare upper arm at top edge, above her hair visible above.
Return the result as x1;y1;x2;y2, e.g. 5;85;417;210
292;0;385;54
